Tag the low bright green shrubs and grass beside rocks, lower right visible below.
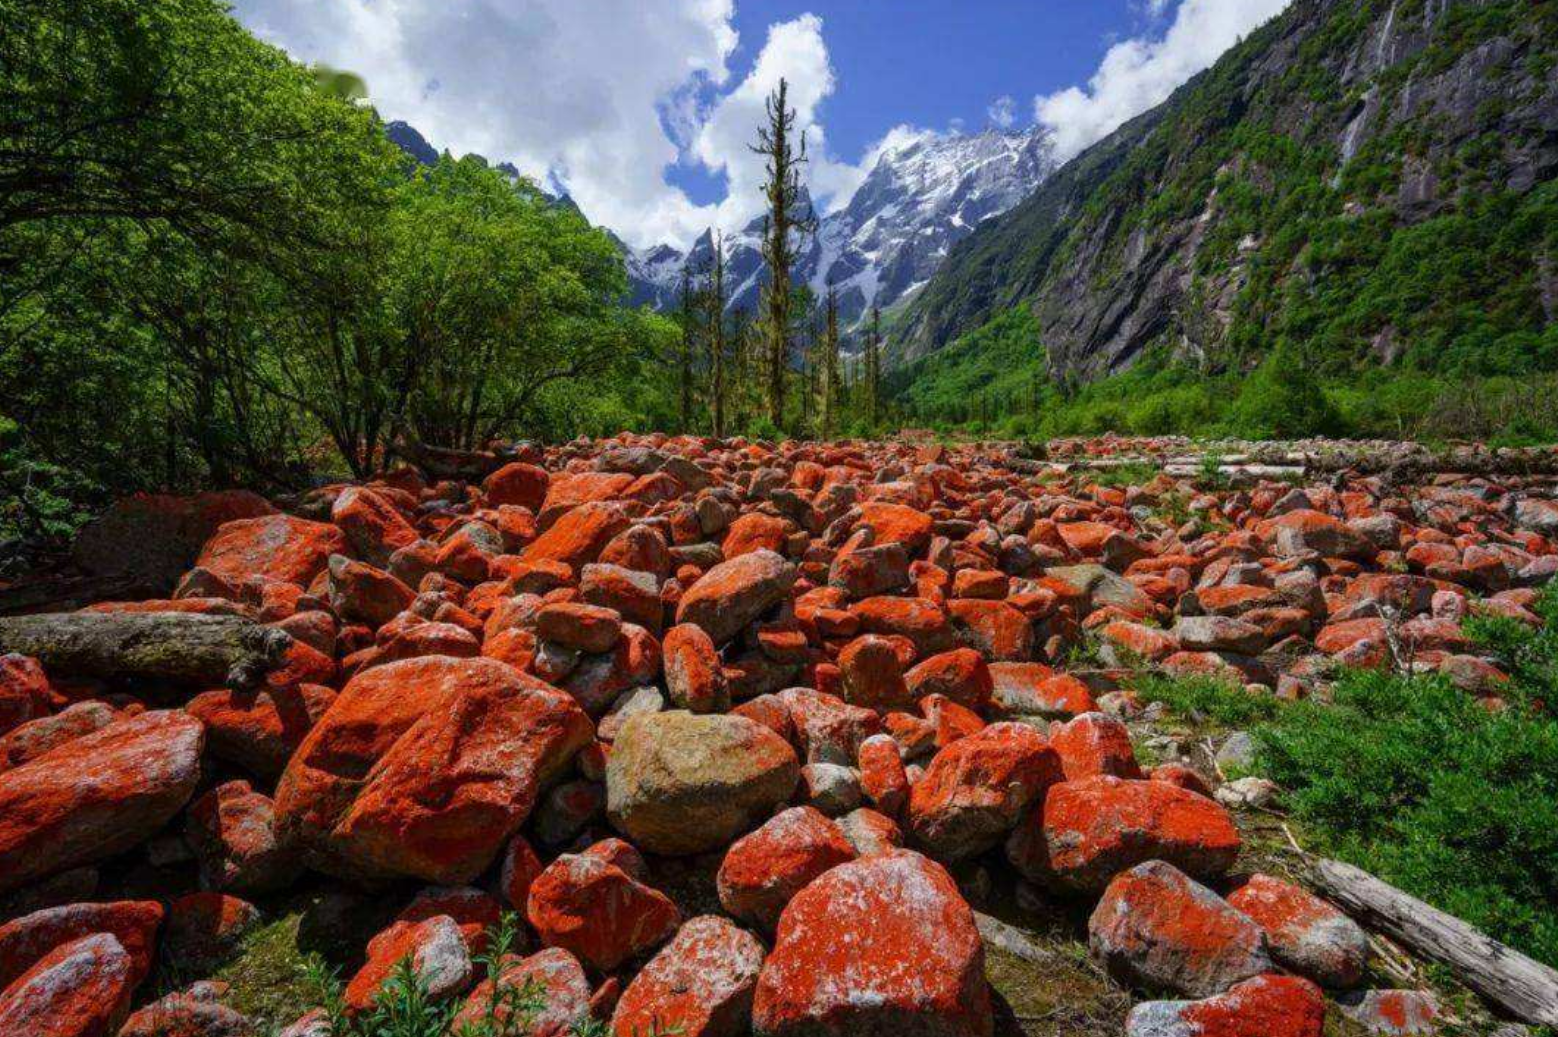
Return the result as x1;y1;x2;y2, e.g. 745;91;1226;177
1136;589;1558;965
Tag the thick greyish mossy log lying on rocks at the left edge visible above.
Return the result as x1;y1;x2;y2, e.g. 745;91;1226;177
0;612;291;690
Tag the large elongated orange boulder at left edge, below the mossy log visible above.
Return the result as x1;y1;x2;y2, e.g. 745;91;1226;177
0;710;206;892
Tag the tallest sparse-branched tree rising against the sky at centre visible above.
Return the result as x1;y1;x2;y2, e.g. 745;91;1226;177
753;79;815;425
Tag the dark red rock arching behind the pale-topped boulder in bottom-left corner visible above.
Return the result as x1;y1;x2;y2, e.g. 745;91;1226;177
0;900;162;990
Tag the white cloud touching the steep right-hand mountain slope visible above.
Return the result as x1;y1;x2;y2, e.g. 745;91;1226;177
1033;0;1290;160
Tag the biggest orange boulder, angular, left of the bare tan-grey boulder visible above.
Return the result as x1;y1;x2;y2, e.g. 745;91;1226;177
276;656;594;884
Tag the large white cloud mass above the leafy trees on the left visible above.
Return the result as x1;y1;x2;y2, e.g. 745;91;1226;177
234;0;737;243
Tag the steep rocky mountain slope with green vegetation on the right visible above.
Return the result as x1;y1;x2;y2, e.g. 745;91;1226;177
894;0;1558;378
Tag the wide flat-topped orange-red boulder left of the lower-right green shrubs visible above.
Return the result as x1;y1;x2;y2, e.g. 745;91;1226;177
1006;774;1240;892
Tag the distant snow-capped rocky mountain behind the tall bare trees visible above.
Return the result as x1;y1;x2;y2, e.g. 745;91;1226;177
628;129;1055;331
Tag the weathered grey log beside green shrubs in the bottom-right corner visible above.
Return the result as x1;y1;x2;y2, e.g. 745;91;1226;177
1307;859;1558;1026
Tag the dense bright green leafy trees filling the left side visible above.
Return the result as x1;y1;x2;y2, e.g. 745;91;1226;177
0;0;676;557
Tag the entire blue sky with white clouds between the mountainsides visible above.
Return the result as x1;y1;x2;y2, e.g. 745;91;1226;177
232;0;1290;246
